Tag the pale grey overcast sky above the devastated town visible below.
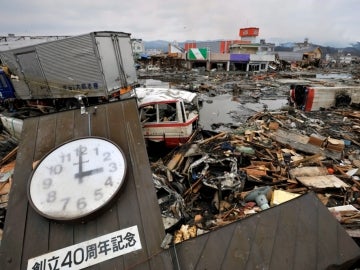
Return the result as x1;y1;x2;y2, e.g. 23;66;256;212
0;0;360;47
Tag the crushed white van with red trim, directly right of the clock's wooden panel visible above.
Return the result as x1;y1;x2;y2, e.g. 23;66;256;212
135;87;199;148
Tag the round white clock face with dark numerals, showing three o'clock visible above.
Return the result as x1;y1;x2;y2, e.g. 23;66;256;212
28;137;126;220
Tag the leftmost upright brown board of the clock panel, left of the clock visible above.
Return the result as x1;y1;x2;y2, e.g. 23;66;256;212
0;118;38;270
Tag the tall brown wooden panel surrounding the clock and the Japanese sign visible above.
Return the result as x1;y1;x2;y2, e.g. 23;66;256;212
0;99;172;269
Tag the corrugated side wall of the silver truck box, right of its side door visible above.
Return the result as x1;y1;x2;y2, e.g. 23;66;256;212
36;34;106;97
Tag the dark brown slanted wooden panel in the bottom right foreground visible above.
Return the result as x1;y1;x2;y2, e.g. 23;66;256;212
176;192;360;269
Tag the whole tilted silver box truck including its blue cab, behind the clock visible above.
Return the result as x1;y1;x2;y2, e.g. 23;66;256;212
0;31;137;112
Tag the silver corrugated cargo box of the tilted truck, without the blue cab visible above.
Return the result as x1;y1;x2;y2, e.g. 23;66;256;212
0;31;137;99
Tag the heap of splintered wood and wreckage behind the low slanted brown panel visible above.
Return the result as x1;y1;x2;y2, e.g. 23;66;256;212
151;109;360;243
